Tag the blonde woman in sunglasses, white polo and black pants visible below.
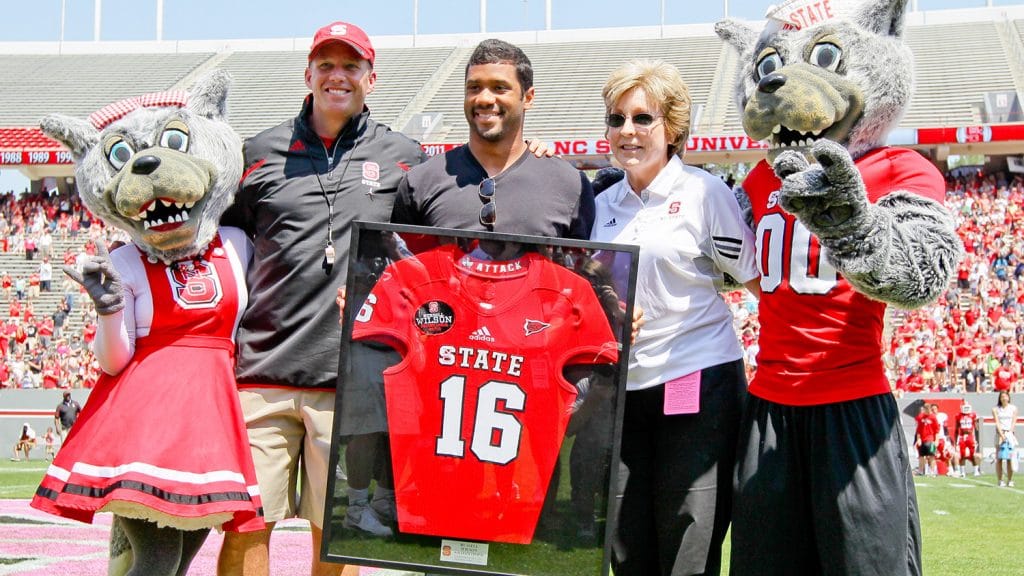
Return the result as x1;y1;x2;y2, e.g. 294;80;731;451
591;60;758;576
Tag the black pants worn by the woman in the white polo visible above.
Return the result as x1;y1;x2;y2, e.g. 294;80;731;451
611;360;746;576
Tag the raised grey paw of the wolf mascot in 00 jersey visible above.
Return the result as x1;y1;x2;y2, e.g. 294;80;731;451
772;140;867;237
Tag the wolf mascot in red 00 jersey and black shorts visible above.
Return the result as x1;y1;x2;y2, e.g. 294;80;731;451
716;0;963;576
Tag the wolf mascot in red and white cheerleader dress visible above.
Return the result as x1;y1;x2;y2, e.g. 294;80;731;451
32;72;264;576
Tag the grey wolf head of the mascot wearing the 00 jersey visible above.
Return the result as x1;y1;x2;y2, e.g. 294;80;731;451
715;0;913;162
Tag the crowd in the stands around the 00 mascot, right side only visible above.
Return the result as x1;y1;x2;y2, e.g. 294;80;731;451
728;166;1024;395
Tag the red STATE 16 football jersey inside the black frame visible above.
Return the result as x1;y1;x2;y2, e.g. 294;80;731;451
352;245;617;544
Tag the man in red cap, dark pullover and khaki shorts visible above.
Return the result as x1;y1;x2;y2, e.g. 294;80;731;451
217;17;426;576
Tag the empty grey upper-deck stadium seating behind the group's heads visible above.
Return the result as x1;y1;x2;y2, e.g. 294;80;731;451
0;13;1024;139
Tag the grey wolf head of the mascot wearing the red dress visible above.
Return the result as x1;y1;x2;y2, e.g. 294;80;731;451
41;71;242;262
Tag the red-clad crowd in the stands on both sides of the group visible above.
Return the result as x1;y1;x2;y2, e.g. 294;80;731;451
6;166;1024;395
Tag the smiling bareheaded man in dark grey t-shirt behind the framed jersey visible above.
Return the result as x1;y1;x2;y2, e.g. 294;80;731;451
391;40;594;240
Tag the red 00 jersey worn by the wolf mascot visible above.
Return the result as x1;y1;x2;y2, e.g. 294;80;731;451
743;148;945;406
